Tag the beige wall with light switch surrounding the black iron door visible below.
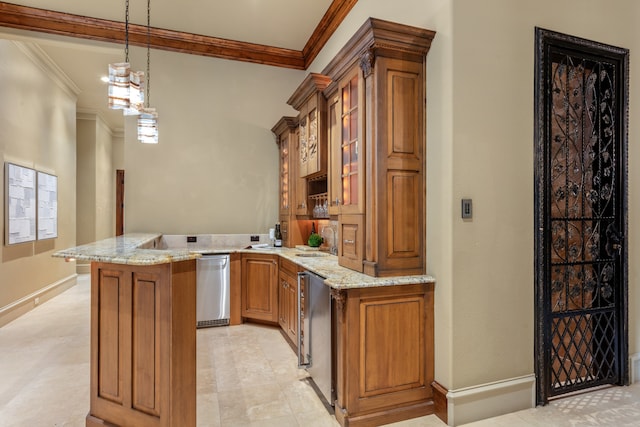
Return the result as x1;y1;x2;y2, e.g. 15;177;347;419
450;0;640;389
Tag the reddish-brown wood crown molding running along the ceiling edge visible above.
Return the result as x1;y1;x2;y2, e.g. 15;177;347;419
0;0;357;70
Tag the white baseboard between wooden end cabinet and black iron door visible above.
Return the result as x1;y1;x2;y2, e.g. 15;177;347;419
447;374;536;426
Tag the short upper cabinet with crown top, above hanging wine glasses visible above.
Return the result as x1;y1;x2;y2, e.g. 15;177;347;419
287;73;330;178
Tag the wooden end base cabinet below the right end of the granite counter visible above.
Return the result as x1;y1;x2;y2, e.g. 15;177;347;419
332;283;434;426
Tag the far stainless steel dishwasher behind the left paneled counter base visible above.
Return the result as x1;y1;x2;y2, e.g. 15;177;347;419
196;254;230;328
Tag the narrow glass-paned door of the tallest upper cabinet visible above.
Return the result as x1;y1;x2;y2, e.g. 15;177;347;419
336;72;365;214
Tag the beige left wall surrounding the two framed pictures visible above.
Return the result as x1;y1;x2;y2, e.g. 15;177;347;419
0;40;76;311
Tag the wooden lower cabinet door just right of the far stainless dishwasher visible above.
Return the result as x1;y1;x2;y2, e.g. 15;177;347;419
241;254;278;324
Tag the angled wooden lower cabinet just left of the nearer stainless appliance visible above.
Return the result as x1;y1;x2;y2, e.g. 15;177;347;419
278;258;298;347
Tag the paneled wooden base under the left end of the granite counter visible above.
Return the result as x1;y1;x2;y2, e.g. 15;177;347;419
86;260;196;427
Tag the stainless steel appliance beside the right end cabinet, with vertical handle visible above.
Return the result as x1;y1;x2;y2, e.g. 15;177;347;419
298;271;334;406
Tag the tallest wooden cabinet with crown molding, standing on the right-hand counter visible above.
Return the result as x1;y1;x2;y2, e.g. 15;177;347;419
323;18;435;276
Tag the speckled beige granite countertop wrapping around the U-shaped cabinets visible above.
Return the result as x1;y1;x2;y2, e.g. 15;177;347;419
53;233;435;289
